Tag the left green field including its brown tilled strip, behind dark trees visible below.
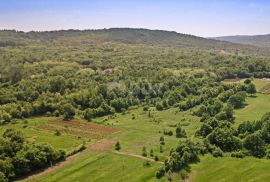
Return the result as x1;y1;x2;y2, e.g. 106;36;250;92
0;117;116;152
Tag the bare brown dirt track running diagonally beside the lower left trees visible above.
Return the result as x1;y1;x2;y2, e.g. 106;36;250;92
17;139;115;181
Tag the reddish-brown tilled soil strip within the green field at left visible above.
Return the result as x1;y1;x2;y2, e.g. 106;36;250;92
38;120;117;139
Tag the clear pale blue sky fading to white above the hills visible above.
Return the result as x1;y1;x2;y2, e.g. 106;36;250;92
0;0;270;37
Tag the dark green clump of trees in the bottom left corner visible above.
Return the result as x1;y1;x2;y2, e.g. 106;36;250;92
0;129;65;181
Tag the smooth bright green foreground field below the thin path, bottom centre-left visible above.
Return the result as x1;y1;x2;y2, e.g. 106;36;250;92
29;152;165;182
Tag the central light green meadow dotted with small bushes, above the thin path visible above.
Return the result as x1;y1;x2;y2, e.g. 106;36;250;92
95;107;201;160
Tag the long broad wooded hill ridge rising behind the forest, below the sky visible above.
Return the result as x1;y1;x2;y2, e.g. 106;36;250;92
0;28;270;55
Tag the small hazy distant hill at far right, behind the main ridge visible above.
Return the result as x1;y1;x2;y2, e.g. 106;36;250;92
213;34;270;47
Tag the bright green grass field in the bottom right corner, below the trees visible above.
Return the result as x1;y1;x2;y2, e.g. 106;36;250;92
189;155;270;182
